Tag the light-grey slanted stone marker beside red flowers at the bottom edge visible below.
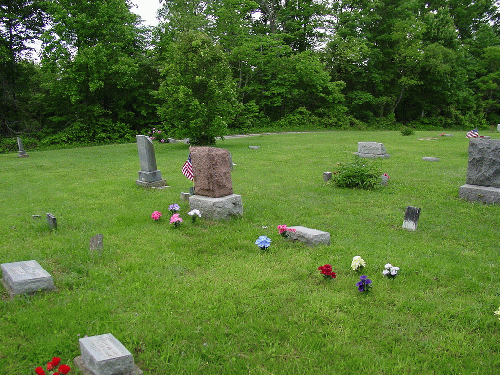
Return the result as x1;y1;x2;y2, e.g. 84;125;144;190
75;333;143;375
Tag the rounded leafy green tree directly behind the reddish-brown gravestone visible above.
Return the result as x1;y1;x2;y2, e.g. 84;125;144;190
158;31;237;145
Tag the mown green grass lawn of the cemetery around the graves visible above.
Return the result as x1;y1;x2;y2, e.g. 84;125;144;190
0;131;500;375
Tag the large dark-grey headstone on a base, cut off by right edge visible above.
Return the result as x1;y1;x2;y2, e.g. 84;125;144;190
458;138;500;204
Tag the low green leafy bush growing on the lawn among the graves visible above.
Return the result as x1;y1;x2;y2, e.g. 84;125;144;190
332;157;382;189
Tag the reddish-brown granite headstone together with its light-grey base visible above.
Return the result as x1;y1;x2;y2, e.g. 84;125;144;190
189;147;243;220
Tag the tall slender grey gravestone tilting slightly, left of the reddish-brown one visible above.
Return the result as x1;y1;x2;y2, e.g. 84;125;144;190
136;135;167;187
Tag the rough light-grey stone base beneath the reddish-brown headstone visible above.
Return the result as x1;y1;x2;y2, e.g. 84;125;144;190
189;194;243;220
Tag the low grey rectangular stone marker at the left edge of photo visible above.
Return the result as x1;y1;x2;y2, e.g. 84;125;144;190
1;260;54;295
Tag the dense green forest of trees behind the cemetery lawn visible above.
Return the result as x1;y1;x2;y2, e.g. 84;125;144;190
0;0;500;151
